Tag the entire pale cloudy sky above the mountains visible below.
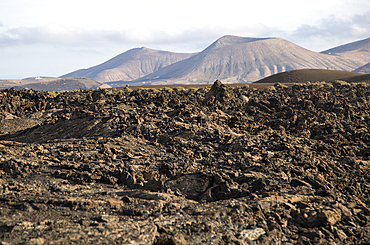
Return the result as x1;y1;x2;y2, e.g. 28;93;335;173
0;0;370;79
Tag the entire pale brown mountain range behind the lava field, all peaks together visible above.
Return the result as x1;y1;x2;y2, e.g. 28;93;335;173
61;35;370;86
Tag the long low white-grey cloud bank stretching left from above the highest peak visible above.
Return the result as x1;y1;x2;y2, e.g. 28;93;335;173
0;22;273;42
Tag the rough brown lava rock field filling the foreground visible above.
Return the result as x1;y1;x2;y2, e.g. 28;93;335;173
0;81;370;245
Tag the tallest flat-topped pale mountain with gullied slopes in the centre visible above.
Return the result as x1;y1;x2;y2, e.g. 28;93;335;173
126;36;365;85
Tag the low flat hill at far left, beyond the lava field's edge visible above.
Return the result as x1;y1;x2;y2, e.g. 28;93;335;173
14;77;103;92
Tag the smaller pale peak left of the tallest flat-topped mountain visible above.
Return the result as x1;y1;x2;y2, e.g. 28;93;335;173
61;47;194;83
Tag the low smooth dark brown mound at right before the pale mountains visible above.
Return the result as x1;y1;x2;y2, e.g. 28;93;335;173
255;69;368;83
